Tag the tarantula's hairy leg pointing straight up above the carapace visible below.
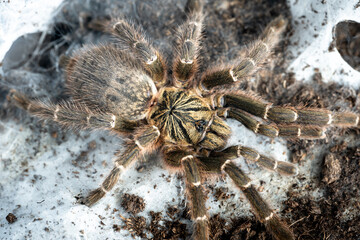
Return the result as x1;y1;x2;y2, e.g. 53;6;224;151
173;13;203;87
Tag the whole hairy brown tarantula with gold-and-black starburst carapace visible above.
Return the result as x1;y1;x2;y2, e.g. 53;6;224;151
11;0;360;240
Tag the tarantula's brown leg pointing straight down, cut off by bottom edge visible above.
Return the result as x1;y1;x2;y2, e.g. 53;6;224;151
181;155;209;240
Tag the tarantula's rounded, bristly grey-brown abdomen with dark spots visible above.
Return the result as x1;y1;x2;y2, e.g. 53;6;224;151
67;45;157;120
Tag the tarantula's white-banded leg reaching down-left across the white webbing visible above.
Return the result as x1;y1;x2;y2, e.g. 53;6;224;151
83;126;160;206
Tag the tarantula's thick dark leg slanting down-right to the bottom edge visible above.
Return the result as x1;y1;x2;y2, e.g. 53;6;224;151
221;160;295;240
